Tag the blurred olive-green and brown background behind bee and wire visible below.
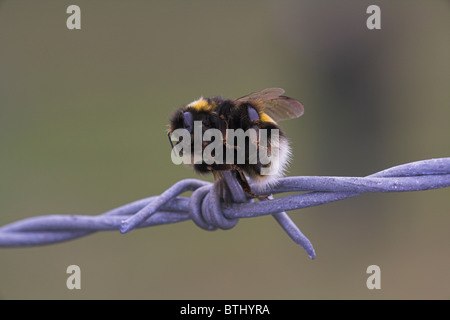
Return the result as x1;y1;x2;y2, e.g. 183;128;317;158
0;0;450;299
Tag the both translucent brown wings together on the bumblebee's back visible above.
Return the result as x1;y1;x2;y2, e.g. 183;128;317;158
235;88;304;121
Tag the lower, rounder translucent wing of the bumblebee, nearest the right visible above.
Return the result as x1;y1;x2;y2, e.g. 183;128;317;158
261;96;304;121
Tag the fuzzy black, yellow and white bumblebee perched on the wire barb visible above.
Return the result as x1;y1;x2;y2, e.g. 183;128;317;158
168;88;304;202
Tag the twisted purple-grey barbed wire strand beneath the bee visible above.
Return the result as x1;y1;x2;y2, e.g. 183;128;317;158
0;158;450;259
